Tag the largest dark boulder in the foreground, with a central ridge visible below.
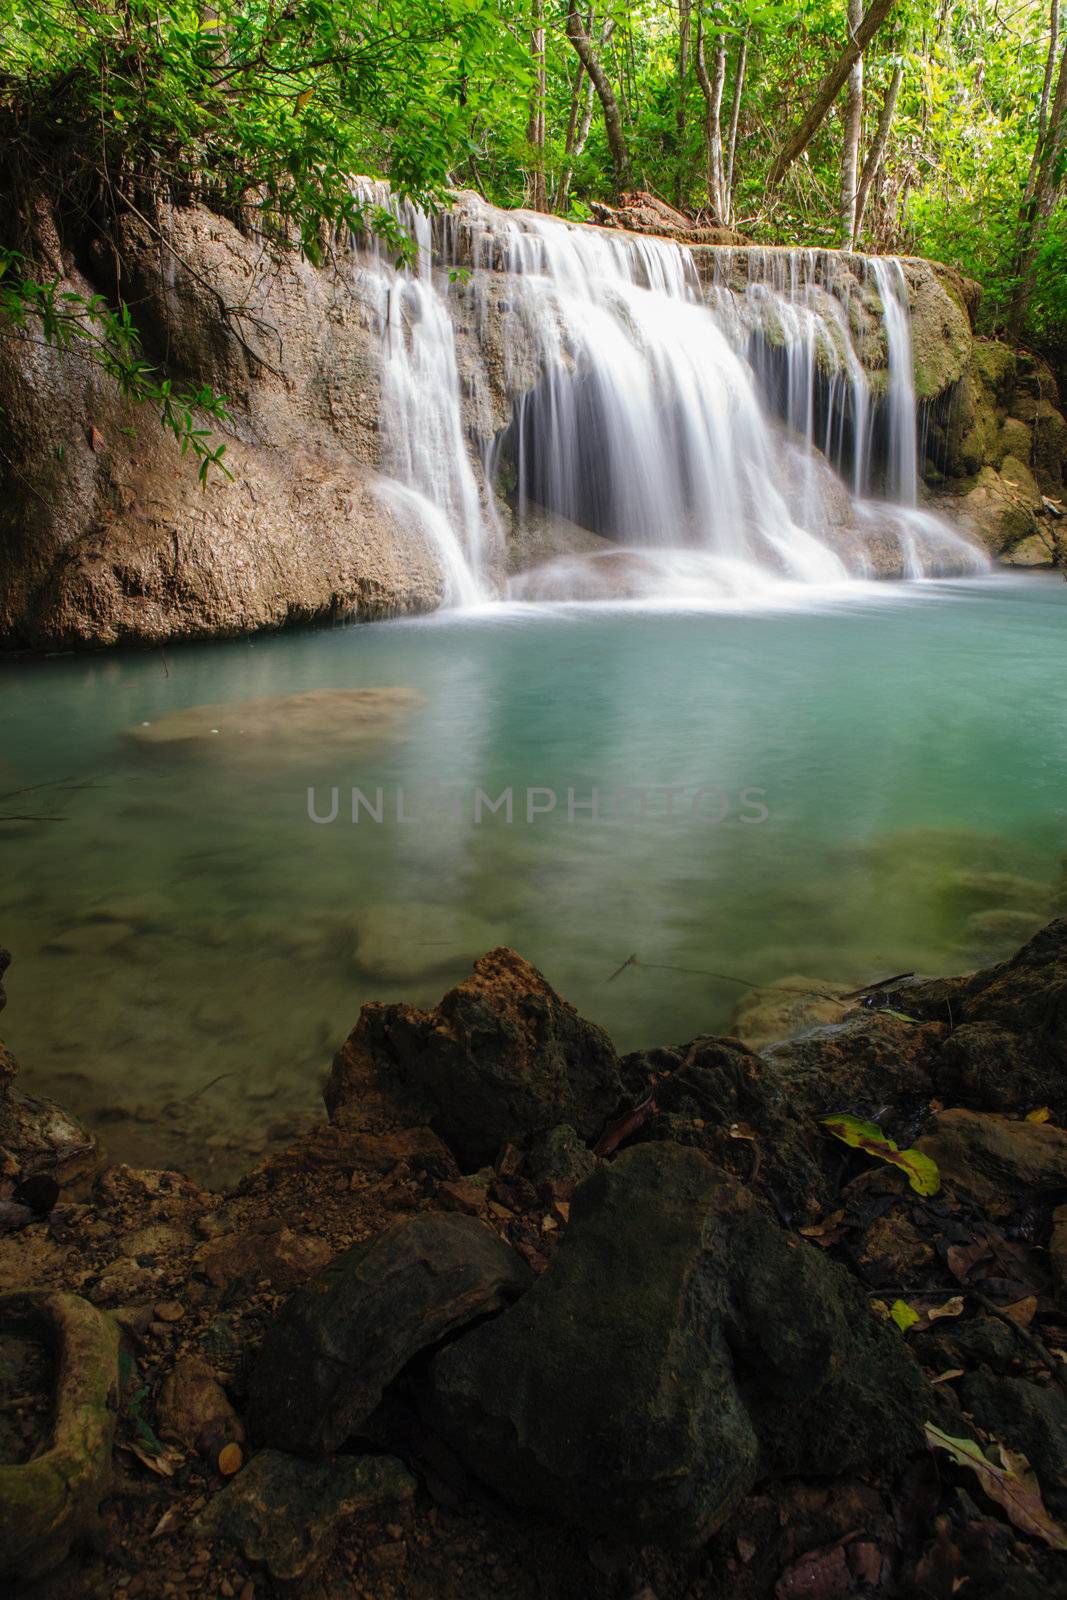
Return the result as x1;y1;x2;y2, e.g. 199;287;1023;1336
421;1144;925;1547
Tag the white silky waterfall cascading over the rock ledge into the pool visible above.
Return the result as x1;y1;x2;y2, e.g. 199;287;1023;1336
347;187;987;603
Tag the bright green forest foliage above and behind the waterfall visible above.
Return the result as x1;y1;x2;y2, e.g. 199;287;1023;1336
0;0;1067;472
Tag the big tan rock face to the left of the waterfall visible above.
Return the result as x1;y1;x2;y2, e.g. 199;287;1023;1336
0;210;442;648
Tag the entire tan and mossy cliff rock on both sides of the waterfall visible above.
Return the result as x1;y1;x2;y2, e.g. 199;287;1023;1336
0;198;1067;648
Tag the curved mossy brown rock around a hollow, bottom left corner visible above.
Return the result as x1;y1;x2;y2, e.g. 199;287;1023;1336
0;1290;118;1579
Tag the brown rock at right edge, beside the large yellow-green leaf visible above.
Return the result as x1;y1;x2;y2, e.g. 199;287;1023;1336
915;1106;1067;1208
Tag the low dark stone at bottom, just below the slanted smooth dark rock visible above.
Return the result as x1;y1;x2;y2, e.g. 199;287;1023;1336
197;1450;414;1582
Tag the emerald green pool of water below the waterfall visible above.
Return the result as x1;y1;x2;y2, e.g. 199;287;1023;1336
0;576;1067;1179
